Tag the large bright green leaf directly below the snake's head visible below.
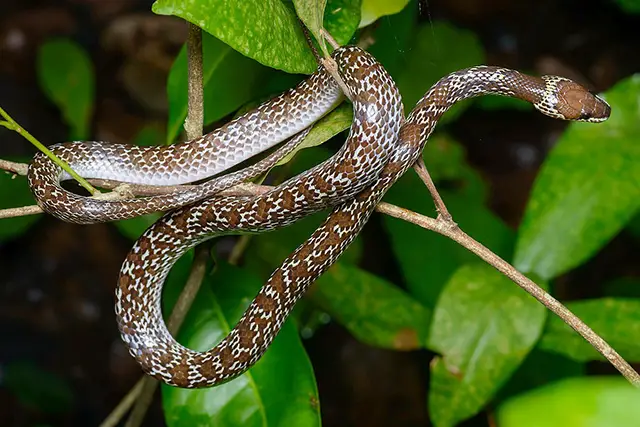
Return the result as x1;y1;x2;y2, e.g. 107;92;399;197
515;74;640;278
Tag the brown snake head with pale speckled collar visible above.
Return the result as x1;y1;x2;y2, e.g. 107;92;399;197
534;76;611;123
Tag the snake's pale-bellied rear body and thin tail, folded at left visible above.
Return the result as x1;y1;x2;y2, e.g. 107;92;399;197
28;54;342;224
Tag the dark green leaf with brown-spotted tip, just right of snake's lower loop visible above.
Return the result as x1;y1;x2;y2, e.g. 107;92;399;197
311;263;430;350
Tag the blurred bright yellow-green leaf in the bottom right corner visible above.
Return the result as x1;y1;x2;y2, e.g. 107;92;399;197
496;378;640;427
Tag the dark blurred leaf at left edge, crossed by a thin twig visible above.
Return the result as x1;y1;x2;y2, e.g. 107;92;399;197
0;171;40;242
